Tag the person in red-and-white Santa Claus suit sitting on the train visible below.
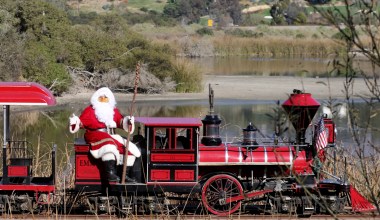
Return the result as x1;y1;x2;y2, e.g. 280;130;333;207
70;87;141;182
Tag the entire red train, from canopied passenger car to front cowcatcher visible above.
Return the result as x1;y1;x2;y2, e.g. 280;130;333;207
0;82;374;216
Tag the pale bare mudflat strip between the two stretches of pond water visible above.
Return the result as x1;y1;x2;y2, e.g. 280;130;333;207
57;75;368;105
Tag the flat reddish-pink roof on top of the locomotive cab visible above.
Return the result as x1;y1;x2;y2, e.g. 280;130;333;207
135;117;202;127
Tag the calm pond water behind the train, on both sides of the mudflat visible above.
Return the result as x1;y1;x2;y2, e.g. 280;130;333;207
0;59;380;162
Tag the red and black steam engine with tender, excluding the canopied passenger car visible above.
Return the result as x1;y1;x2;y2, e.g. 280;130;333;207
75;87;373;216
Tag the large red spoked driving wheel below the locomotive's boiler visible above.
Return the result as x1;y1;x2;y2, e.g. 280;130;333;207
202;174;243;216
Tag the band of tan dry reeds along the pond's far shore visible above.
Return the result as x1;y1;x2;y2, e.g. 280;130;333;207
141;24;344;58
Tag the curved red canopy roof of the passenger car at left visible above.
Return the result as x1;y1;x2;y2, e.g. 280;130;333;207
0;82;56;105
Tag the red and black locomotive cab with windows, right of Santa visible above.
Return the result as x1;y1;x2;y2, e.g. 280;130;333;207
136;117;201;185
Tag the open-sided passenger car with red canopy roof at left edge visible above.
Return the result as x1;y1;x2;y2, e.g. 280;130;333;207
0;82;56;212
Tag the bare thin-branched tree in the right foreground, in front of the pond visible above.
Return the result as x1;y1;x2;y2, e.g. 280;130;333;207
315;0;380;213
